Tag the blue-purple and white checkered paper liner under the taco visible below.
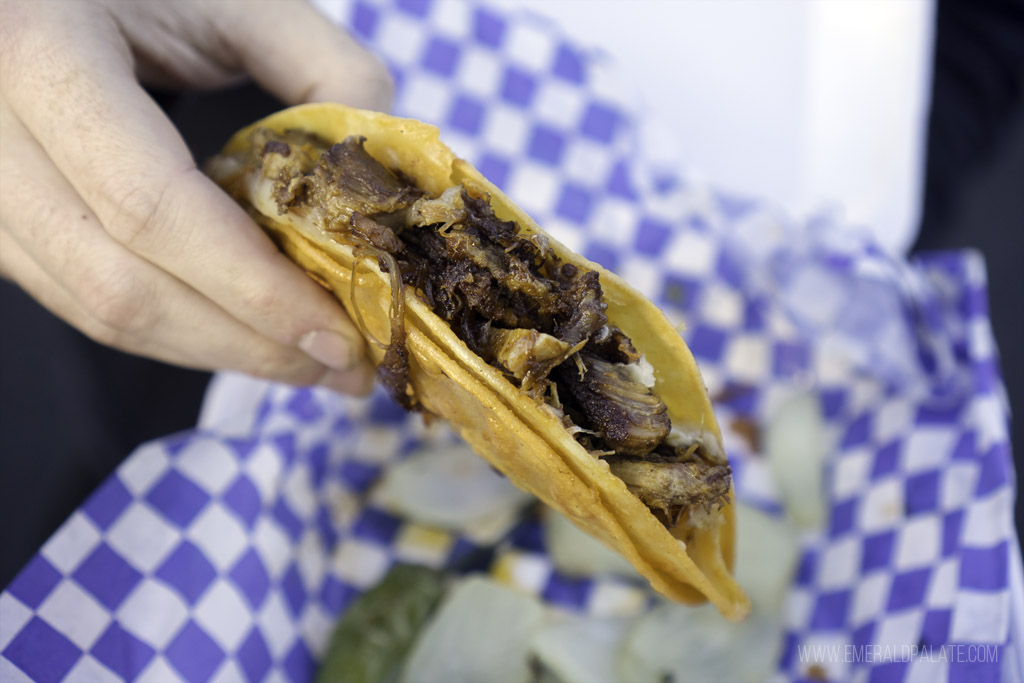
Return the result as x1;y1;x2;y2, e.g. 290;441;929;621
0;1;1020;682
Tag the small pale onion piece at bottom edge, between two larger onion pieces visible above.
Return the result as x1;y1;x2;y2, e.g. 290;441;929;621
530;616;632;683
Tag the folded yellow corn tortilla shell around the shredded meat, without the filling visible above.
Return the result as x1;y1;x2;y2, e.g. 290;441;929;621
207;103;750;620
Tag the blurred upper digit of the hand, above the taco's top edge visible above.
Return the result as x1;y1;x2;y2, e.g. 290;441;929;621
209;0;394;112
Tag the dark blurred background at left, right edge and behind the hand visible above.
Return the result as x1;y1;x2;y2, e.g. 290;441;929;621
0;0;1024;587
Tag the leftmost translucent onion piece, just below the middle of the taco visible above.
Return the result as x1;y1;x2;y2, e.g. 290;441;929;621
373;443;532;540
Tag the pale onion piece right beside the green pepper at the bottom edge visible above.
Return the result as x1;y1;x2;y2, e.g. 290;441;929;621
401;577;547;683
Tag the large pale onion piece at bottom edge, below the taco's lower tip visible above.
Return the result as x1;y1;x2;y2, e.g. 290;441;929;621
616;603;782;683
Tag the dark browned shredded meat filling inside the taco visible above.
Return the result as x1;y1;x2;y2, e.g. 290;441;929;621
254;129;730;528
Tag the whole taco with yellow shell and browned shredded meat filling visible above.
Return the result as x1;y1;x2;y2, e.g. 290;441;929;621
207;104;749;618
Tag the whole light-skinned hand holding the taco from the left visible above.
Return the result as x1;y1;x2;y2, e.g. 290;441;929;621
0;0;391;393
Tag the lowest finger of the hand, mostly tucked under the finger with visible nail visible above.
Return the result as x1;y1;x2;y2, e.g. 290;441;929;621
0;104;372;393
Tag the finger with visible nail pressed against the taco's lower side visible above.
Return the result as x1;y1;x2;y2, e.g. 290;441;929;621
0;3;364;378
